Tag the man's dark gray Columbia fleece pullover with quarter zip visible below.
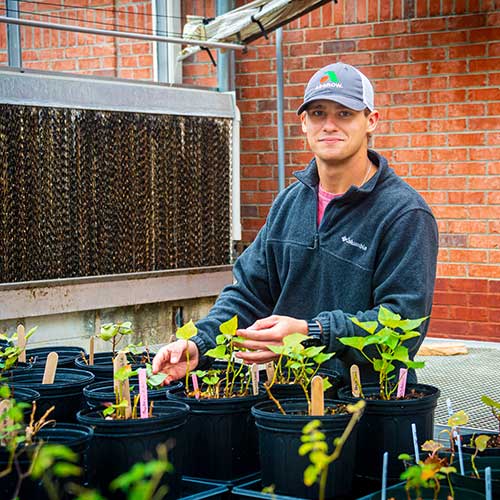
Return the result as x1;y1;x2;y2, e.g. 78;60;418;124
193;150;438;383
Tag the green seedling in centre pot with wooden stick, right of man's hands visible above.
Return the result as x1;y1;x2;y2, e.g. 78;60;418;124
264;333;335;412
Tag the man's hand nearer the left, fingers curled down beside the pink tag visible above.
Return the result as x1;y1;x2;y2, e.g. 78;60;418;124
153;340;200;384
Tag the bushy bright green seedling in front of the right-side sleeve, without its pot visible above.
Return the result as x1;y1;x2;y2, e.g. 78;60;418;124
339;306;427;400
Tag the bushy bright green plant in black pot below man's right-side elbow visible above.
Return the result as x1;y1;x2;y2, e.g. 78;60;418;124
339;306;440;484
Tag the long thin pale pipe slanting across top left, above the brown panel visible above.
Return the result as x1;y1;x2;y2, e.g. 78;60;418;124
0;16;245;50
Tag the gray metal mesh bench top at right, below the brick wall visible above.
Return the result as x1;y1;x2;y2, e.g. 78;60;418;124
415;347;500;430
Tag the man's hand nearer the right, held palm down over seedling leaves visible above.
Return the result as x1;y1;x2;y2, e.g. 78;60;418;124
236;314;307;363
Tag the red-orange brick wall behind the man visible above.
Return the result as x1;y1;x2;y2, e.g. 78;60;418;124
0;0;500;341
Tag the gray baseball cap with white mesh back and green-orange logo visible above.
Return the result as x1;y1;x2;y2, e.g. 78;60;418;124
297;63;375;115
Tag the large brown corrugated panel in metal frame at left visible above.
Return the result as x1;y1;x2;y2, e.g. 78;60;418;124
0;105;231;283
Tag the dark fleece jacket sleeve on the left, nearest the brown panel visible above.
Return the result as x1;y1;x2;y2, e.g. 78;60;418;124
192;225;274;367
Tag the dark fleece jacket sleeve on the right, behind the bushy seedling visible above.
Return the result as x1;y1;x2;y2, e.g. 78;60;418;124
314;209;438;365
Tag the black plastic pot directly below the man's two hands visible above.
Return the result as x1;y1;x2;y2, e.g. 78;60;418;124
167;389;266;482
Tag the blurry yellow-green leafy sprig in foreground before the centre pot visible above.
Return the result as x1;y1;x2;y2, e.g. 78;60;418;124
299;400;366;500
